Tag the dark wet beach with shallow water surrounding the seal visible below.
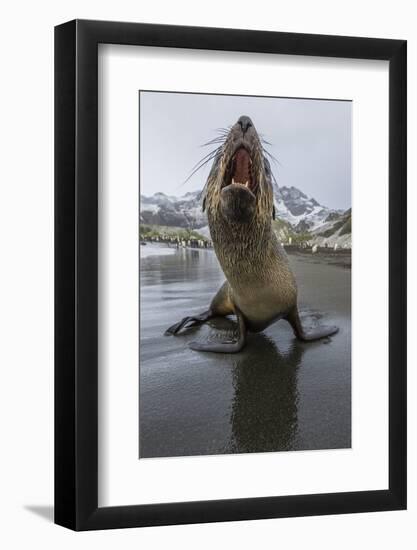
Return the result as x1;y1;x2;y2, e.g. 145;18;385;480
139;244;351;458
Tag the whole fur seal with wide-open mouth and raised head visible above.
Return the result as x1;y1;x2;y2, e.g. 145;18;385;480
165;116;338;353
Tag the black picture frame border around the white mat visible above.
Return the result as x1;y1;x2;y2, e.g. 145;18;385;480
55;20;407;530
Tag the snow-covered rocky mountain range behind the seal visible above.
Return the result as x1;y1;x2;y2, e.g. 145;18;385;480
140;184;350;246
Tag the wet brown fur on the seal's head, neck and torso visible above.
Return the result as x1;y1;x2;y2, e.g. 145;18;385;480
205;119;297;330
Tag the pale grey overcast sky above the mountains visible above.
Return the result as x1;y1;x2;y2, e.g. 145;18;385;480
140;92;352;209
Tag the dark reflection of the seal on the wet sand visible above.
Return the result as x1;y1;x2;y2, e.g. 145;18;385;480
230;334;304;453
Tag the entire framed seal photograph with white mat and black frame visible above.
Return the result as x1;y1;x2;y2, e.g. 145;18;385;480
55;20;406;530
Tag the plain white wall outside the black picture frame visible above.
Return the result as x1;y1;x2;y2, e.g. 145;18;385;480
0;0;417;550
